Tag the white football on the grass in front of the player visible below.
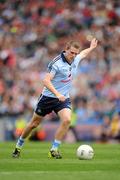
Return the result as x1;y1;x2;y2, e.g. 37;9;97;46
77;144;94;160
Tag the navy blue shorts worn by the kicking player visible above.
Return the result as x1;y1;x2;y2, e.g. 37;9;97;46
35;95;71;116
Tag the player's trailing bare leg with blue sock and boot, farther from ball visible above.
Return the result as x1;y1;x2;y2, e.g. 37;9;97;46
12;113;42;158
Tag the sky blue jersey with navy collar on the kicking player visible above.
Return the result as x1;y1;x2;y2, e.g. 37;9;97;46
42;52;81;98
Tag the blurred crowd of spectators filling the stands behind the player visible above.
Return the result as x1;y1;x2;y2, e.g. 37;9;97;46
0;0;120;141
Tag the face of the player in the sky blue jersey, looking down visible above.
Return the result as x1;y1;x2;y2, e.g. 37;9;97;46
66;46;79;61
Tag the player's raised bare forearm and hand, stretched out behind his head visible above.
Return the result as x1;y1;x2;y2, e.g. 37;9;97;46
79;38;98;59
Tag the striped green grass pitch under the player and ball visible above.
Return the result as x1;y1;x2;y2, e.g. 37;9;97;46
0;142;120;180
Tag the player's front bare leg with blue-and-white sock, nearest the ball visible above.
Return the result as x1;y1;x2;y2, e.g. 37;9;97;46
48;108;71;159
